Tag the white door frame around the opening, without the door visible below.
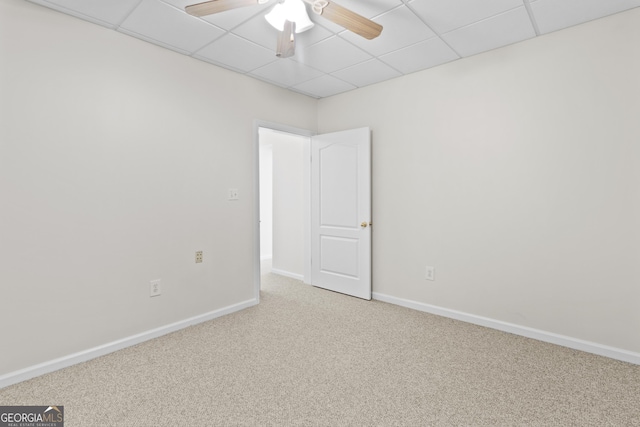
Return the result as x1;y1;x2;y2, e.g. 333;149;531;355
253;120;316;303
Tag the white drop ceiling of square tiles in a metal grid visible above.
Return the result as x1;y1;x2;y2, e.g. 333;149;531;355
25;0;640;98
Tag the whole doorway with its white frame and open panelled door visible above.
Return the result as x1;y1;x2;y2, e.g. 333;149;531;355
254;123;371;303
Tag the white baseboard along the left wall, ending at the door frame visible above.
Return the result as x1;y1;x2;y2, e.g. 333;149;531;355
0;299;257;389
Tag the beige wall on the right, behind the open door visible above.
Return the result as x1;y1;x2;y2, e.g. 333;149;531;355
318;9;640;352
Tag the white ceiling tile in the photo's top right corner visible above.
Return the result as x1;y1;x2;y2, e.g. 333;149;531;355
531;0;640;34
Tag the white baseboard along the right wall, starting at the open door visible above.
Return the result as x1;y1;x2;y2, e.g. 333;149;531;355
372;292;640;365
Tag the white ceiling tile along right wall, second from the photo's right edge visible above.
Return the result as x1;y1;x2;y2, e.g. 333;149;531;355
442;6;536;56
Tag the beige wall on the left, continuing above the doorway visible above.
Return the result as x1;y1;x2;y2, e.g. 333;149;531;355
0;0;317;375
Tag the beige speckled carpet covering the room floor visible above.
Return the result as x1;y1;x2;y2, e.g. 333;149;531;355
0;275;640;427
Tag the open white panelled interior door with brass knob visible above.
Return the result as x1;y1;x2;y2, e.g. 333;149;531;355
311;128;371;300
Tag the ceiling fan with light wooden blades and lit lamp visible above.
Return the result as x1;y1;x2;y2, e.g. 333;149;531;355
185;0;382;58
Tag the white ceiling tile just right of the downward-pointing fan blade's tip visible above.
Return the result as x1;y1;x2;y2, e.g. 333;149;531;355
293;36;371;73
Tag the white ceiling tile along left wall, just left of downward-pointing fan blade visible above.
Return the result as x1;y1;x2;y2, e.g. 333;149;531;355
194;34;278;72
